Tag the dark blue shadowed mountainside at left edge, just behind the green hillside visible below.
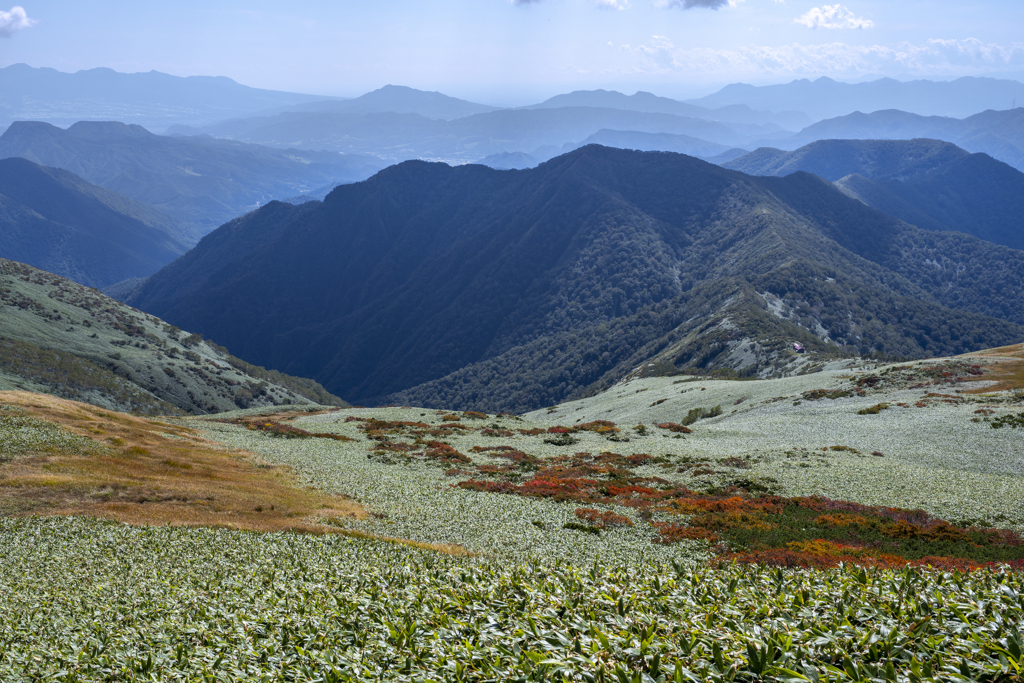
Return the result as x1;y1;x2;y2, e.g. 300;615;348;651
0;159;187;287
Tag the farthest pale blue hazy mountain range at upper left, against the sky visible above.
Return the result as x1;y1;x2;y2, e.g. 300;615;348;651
0;63;325;131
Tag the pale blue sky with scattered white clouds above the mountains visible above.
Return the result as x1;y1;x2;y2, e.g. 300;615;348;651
0;0;1024;104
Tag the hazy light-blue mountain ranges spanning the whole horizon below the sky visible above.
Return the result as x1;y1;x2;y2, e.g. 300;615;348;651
8;65;1024;179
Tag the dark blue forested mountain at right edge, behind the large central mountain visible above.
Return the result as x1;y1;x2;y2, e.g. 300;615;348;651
723;139;1024;249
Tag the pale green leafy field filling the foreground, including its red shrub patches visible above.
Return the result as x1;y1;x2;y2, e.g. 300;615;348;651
0;356;1024;682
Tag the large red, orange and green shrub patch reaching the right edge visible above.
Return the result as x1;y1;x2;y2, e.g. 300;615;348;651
450;438;1024;569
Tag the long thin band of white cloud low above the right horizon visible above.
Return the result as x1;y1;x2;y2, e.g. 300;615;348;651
623;36;1024;81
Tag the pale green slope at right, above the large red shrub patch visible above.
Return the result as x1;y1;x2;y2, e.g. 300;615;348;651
523;356;1024;528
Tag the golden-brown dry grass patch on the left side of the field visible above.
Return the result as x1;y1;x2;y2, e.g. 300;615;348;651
0;391;366;532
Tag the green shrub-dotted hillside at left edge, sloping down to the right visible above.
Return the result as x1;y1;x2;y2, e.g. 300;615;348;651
0;259;345;415
